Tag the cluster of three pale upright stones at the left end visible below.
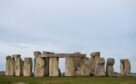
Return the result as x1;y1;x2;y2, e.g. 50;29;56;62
5;54;32;76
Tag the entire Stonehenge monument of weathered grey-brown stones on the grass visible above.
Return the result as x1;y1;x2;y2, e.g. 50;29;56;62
5;51;131;77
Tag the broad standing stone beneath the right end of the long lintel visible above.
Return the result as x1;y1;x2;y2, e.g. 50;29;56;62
80;58;90;76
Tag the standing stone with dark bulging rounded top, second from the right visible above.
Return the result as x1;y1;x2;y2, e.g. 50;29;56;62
106;58;115;76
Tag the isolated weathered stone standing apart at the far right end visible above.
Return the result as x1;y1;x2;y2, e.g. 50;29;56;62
120;59;131;76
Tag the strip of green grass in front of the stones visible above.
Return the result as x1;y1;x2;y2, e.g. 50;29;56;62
0;76;136;84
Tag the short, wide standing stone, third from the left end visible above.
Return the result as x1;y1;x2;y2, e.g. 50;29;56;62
23;58;32;76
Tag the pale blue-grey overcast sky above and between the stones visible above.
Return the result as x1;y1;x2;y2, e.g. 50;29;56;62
0;0;136;72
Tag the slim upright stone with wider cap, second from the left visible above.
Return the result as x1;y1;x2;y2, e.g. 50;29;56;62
13;54;22;76
